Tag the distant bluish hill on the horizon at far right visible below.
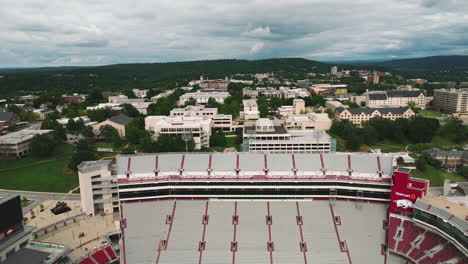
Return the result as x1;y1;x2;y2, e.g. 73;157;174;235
355;55;468;71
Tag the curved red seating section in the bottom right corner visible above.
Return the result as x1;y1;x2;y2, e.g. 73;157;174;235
388;217;468;264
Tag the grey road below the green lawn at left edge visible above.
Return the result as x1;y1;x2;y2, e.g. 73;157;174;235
0;190;80;214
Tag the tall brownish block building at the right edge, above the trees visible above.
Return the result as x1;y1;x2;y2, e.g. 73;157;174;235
432;88;468;114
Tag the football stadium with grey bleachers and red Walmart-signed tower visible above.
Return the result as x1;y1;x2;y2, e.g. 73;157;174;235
104;153;468;264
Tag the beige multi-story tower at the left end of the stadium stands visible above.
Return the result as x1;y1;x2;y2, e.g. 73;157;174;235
78;160;119;215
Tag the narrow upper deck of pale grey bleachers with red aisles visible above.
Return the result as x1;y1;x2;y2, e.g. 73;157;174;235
115;152;393;179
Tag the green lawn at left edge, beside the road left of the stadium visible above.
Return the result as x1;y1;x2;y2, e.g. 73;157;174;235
0;144;78;192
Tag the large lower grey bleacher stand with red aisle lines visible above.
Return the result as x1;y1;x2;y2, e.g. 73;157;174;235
122;200;387;264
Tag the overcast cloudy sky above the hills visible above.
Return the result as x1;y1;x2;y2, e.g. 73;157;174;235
0;0;468;67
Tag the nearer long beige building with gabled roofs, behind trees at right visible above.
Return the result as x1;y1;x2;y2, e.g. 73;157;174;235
335;107;416;126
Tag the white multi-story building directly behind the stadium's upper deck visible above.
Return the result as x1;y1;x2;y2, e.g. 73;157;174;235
243;118;332;153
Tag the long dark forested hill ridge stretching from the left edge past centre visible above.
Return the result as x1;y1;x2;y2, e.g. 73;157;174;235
0;58;331;93
